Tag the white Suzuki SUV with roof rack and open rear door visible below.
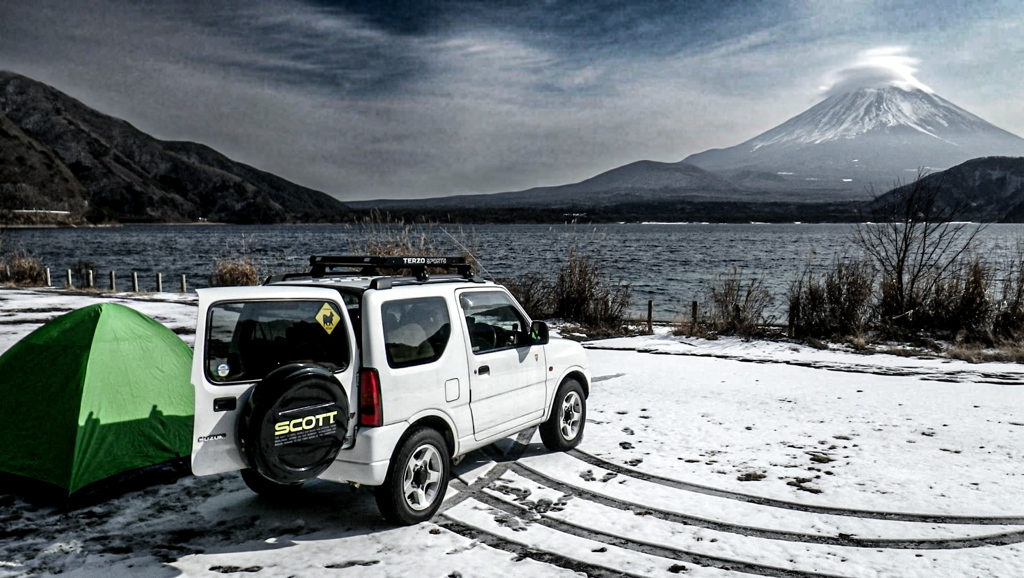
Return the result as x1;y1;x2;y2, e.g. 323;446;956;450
191;256;590;524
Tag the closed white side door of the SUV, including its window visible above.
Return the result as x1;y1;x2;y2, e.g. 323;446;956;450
459;289;547;440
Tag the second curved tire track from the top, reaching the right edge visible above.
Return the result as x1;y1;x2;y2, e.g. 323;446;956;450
512;463;1024;550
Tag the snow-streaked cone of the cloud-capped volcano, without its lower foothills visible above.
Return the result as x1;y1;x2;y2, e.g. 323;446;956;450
684;86;1024;201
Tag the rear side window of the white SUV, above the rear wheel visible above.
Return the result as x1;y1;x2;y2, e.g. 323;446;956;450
381;297;452;368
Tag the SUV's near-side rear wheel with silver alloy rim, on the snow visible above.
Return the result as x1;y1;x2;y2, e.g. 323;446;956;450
375;427;452;526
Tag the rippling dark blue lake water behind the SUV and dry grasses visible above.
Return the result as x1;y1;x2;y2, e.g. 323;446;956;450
6;224;1024;320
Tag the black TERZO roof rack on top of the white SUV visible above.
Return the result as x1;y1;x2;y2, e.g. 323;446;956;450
260;255;482;289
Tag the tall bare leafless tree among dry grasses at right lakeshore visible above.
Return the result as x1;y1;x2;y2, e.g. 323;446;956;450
853;170;982;329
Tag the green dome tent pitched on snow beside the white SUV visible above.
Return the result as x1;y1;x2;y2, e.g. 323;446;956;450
0;303;193;503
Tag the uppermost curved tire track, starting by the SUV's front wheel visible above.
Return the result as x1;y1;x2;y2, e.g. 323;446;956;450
566;449;1024;524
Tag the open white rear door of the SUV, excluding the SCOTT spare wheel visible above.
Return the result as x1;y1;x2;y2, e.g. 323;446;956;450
191;286;358;476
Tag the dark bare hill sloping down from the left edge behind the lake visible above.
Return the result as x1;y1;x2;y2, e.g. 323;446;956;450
0;71;349;222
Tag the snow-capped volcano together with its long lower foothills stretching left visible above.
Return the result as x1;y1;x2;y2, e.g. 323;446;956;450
352;77;1024;222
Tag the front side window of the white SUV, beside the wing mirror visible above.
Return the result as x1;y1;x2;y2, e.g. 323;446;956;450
459;291;529;354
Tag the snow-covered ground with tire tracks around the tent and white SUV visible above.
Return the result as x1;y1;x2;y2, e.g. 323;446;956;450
0;290;1024;577
